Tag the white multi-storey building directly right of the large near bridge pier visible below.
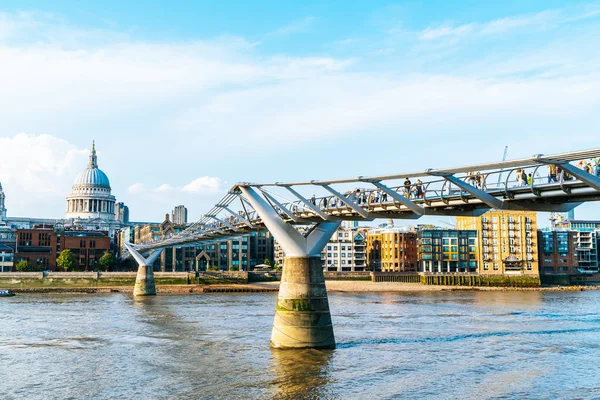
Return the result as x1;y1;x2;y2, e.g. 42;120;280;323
321;224;367;272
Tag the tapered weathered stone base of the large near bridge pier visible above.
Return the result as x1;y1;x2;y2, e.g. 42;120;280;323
271;257;335;349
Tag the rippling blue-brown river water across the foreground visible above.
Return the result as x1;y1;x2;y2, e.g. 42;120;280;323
0;291;600;400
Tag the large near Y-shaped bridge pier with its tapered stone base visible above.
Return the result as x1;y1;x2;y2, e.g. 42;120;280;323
240;186;340;349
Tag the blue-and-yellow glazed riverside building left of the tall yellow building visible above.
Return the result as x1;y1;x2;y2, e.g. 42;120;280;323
417;229;479;273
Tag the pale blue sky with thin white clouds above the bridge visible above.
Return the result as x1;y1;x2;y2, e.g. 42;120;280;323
0;0;600;221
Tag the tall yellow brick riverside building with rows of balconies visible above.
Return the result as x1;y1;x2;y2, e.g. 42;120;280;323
456;210;539;276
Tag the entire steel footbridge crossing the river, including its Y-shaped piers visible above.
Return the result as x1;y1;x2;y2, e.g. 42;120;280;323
126;148;600;348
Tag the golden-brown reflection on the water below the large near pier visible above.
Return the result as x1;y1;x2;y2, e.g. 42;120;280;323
271;349;334;399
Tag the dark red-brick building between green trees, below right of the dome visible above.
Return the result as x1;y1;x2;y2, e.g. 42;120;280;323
60;231;110;271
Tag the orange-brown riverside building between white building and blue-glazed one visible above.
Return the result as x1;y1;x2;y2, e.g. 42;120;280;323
367;227;417;272
